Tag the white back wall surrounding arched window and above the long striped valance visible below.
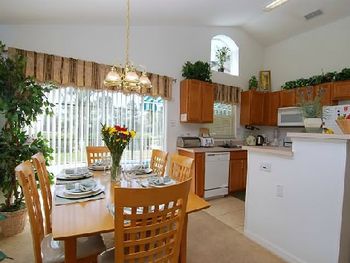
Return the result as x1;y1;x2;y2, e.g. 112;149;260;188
0;25;263;155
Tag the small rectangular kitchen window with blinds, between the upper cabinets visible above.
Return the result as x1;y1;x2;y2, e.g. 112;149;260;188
206;103;236;138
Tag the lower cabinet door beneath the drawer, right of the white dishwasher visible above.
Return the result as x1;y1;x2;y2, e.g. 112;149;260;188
229;159;246;193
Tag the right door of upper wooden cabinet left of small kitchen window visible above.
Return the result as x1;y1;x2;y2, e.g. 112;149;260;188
201;82;214;122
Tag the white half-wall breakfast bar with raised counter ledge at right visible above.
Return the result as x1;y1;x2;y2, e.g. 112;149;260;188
244;133;350;263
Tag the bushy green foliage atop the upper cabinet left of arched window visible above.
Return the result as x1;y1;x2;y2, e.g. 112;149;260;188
182;61;211;82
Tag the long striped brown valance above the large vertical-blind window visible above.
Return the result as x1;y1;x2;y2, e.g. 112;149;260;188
9;48;173;100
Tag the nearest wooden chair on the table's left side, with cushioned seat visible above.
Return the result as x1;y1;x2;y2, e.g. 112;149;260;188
15;161;105;263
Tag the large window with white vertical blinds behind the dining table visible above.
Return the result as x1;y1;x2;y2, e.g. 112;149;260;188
29;87;165;165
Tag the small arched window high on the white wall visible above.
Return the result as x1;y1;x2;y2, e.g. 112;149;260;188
210;35;239;76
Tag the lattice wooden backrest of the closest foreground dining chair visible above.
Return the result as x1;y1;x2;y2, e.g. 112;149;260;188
114;178;190;263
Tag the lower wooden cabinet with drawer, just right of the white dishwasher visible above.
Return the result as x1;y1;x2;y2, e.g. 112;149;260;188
229;150;247;193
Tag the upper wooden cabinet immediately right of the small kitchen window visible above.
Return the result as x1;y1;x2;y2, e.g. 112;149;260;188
240;90;265;125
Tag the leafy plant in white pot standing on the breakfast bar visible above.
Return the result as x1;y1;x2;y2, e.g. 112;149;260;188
297;87;324;133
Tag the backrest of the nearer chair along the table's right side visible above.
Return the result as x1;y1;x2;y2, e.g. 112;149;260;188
169;154;193;182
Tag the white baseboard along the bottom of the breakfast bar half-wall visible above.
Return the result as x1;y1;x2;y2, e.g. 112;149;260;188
244;229;307;263
